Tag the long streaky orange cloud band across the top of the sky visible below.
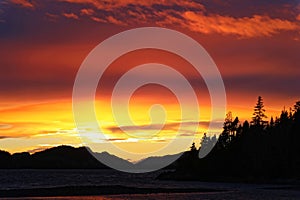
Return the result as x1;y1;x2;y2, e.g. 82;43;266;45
6;0;300;38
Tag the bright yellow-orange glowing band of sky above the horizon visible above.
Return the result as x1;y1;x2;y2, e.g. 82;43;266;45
0;96;286;160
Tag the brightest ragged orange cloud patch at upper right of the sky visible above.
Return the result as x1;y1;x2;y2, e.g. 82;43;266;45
182;11;300;38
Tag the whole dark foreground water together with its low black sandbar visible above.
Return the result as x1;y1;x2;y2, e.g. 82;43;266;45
0;169;300;200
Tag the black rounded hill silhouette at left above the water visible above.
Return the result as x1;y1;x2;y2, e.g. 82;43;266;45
0;145;108;169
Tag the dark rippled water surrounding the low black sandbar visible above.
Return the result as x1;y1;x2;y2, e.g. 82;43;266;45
0;170;300;200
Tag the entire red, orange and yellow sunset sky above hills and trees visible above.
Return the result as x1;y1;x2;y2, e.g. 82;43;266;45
0;0;300;160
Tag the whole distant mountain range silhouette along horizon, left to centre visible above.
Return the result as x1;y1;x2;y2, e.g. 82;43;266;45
0;145;178;169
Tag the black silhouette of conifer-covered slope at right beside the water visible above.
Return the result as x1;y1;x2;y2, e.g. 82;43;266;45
159;96;300;182
